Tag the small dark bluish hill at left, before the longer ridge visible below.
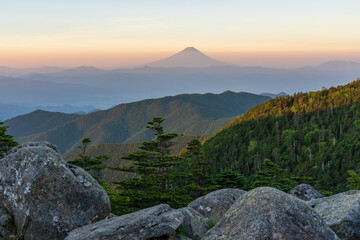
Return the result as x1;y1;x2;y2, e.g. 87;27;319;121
4;110;82;139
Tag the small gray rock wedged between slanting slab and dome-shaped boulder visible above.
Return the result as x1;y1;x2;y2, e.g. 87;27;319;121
179;207;210;239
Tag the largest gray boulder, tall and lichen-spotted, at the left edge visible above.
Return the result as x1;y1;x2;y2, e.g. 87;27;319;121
0;142;110;240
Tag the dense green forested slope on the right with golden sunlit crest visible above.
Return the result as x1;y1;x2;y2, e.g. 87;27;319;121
204;79;360;192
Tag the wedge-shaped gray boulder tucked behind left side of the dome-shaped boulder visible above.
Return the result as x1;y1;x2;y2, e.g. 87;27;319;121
188;188;246;222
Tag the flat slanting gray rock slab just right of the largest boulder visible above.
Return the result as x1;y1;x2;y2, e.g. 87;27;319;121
65;204;183;240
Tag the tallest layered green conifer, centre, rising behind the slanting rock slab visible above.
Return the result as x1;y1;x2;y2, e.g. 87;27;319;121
112;117;188;212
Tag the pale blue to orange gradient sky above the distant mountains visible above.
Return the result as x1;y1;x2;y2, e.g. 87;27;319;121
0;0;360;67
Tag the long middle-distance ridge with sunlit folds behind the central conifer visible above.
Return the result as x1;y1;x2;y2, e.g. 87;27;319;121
16;91;270;153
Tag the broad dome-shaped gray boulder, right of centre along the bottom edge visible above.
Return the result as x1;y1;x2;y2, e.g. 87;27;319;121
203;187;339;240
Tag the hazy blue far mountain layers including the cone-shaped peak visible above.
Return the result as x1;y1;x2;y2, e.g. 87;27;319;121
0;48;360;109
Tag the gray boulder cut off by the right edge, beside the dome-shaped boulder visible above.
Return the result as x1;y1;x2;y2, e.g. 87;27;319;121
310;191;360;240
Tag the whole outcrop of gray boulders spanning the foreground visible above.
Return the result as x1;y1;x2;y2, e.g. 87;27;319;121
0;142;360;240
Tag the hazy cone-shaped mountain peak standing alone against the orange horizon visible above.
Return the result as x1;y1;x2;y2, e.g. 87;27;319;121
146;47;229;68
